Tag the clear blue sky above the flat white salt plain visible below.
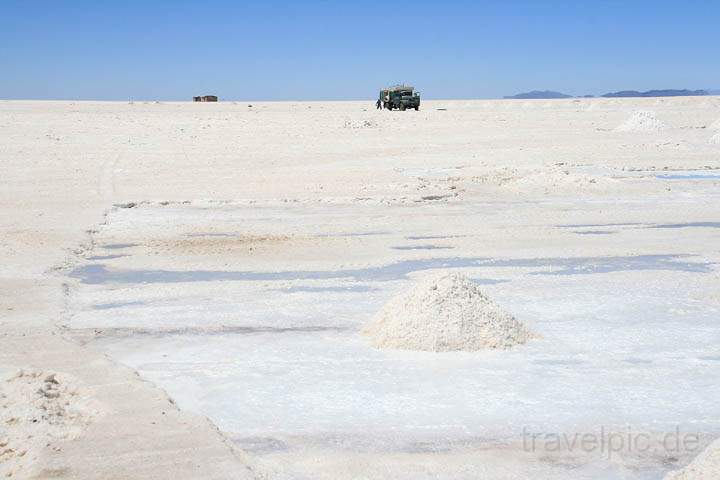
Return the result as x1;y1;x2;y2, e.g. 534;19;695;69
0;0;720;100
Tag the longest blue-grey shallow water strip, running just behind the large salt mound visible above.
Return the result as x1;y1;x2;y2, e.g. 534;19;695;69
69;255;711;284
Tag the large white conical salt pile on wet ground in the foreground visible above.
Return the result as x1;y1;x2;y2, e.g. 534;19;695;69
363;273;534;352
